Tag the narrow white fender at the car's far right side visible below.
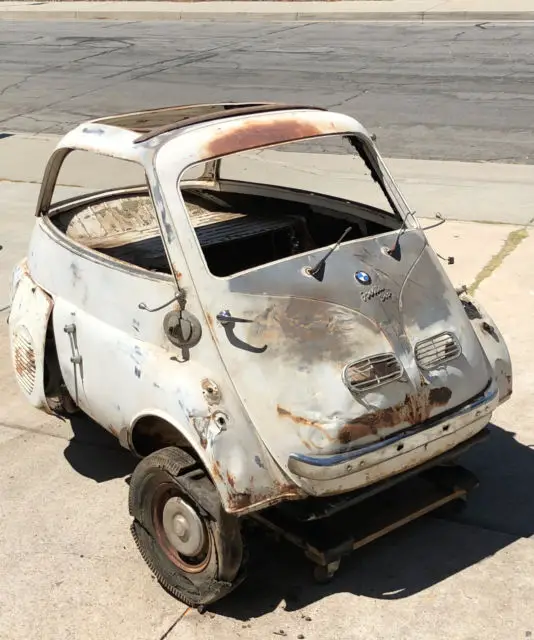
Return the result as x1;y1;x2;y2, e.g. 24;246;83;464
458;291;513;404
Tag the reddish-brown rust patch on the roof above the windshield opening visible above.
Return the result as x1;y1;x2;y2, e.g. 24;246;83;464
200;114;336;159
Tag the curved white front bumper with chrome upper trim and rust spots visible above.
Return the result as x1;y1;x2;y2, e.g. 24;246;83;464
288;380;499;495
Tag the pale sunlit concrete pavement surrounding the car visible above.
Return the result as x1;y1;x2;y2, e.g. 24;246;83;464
0;135;534;640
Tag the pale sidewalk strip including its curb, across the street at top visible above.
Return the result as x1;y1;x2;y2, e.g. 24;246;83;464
0;0;534;22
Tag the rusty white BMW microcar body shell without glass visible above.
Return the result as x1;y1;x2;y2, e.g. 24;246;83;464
9;103;512;514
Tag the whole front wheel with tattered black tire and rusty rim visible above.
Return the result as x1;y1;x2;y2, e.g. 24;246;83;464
129;447;246;607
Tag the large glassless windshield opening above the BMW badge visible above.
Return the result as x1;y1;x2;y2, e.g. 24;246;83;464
178;135;402;277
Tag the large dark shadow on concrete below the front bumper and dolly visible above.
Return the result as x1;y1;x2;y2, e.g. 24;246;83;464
210;425;534;621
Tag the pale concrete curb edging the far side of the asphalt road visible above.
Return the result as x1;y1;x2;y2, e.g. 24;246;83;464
0;5;534;22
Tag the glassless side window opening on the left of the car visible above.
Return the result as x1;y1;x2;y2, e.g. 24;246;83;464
48;150;170;273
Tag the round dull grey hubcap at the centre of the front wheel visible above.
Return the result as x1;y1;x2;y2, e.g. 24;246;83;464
162;497;206;557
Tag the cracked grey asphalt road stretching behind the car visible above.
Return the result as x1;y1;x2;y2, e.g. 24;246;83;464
0;22;534;164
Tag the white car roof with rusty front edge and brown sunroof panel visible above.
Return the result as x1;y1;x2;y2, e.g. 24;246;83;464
52;102;369;168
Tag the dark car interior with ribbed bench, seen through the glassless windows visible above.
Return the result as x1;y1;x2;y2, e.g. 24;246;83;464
50;181;401;277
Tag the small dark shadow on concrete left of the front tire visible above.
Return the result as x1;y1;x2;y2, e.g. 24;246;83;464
64;412;138;482
